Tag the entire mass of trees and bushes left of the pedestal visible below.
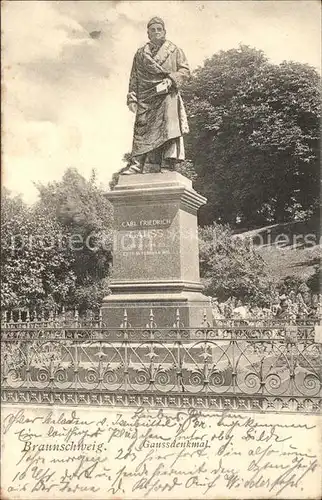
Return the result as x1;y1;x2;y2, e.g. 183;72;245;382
1;169;112;309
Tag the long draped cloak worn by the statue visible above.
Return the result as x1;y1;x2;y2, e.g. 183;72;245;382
128;41;190;156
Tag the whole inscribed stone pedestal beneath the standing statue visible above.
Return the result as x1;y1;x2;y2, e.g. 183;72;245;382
102;172;211;328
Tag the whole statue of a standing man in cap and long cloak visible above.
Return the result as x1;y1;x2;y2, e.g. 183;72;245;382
121;17;190;174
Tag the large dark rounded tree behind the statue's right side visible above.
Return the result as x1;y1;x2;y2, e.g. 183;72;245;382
184;46;320;227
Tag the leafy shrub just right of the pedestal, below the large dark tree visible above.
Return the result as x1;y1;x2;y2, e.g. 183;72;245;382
199;223;274;305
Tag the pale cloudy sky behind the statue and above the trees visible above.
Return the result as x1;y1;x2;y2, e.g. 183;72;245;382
2;0;321;203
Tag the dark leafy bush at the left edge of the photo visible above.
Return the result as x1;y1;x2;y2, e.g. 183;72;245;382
1;189;76;309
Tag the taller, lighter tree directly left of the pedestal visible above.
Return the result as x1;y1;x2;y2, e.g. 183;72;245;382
38;169;113;309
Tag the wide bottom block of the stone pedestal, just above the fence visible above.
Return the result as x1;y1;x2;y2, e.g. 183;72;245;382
102;292;212;328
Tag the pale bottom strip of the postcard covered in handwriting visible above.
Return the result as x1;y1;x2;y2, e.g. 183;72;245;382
2;408;320;498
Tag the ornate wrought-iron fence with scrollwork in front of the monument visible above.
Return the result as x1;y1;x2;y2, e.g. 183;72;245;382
1;310;322;413
